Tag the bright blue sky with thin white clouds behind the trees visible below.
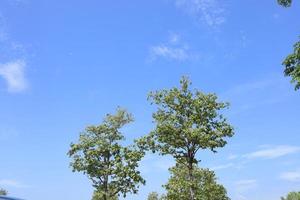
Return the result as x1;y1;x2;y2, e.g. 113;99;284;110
0;0;300;200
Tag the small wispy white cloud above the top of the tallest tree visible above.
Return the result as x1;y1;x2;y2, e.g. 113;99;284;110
150;33;198;61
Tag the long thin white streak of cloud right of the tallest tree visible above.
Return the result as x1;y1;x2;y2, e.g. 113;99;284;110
244;145;300;159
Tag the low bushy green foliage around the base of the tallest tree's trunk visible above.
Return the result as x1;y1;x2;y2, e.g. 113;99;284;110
164;164;229;200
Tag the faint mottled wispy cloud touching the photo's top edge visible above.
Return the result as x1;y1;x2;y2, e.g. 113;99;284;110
175;0;226;27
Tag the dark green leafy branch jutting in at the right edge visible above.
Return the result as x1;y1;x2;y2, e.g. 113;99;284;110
283;38;300;90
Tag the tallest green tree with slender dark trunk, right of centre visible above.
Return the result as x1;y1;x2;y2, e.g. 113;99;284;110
137;77;234;200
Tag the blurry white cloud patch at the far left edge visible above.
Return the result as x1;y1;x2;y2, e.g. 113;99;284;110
0;60;28;92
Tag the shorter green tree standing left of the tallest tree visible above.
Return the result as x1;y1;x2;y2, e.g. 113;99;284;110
68;108;145;200
